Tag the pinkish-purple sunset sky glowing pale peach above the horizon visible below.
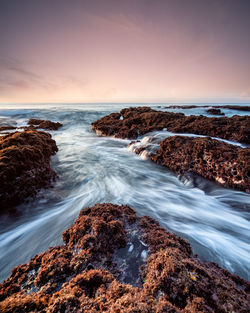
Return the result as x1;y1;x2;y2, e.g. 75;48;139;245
0;0;250;103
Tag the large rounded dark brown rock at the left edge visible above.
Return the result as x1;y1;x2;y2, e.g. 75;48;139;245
0;130;58;210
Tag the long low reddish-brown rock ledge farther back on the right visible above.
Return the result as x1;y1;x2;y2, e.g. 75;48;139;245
92;107;250;143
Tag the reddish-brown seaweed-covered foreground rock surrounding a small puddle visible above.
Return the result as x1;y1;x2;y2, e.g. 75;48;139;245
0;204;250;313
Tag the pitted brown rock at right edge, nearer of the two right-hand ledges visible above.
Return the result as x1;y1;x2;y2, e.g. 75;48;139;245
149;136;250;192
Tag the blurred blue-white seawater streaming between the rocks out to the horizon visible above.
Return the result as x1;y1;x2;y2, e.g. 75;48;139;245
0;103;250;281
